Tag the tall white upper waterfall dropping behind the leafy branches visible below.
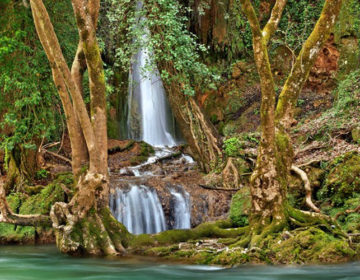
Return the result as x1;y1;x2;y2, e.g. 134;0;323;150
128;19;177;147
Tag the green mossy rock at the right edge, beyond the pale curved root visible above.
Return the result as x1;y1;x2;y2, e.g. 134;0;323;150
317;153;360;206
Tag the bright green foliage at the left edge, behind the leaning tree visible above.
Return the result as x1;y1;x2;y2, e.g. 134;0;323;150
0;0;77;155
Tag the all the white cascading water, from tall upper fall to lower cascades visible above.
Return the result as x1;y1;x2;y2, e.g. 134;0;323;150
110;2;193;234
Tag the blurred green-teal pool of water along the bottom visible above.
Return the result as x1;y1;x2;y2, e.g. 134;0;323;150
0;246;360;280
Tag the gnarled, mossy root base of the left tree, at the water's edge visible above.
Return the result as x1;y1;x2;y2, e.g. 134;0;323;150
50;173;129;255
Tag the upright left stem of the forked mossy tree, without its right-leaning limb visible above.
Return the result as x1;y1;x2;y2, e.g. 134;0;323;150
241;1;287;234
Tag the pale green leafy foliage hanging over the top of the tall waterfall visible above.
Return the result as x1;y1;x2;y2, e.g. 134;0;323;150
108;0;219;95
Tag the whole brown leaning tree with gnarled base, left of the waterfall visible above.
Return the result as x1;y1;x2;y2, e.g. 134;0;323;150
30;0;128;255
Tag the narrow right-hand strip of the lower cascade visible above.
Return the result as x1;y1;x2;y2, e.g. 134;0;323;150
170;187;191;229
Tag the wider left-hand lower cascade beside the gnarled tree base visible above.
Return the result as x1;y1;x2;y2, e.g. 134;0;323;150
110;185;166;234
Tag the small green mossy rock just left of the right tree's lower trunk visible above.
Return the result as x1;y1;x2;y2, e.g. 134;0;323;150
230;187;251;227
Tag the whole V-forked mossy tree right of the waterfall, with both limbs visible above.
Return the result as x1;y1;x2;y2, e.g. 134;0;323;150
240;0;342;245
